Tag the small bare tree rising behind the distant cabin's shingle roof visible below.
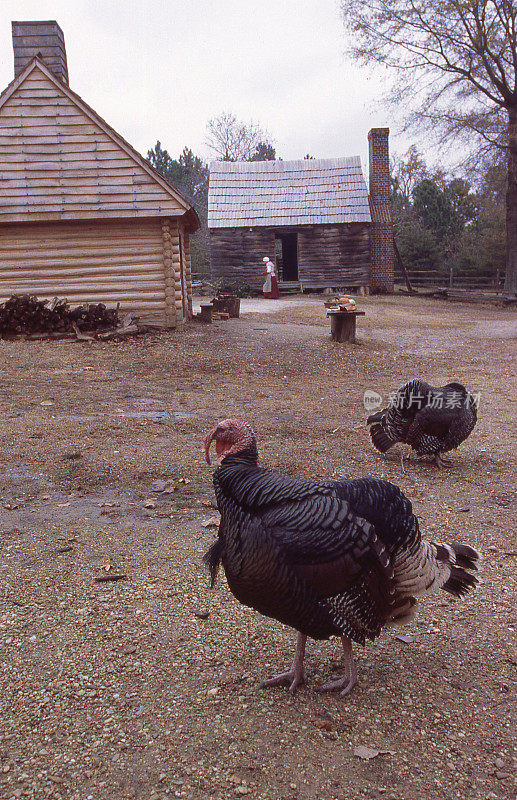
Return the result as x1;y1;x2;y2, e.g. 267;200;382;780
205;112;275;161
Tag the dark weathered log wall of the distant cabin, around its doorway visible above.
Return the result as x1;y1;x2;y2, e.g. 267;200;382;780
210;223;371;288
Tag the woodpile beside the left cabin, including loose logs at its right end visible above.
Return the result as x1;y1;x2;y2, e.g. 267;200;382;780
0;294;144;341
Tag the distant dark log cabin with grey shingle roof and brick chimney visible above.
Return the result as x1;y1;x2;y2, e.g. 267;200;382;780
208;128;393;293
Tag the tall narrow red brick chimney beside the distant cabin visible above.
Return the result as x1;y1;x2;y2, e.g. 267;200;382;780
368;128;393;294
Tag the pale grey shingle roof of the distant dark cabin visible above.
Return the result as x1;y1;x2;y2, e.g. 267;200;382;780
208;156;371;228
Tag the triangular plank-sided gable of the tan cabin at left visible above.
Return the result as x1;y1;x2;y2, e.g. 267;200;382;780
0;57;199;231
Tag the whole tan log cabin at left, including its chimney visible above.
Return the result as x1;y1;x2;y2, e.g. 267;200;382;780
0;21;199;327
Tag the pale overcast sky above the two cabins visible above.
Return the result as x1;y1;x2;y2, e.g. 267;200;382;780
0;0;411;172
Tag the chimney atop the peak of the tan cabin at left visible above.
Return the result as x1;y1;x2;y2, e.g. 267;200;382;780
12;20;68;84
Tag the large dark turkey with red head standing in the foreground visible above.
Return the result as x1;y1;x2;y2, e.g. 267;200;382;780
204;419;479;695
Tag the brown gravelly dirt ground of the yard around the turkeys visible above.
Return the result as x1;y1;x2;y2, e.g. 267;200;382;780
0;297;517;800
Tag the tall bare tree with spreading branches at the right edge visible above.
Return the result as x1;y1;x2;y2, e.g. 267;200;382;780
341;0;517;296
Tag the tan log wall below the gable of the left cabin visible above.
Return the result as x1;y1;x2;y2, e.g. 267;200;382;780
0;218;189;327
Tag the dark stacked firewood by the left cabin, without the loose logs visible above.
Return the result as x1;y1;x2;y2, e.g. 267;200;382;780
0;294;120;337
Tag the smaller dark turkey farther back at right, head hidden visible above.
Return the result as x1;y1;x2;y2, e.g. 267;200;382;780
366;380;477;467
